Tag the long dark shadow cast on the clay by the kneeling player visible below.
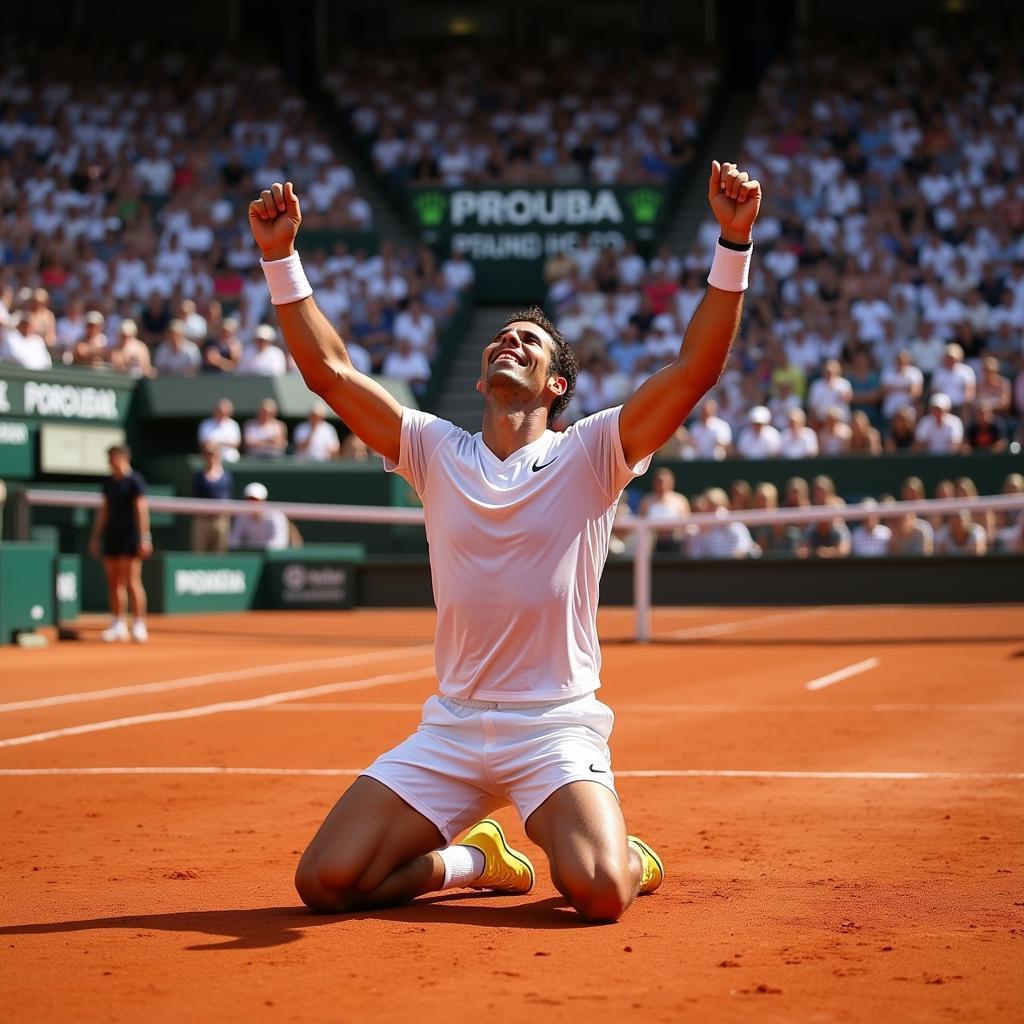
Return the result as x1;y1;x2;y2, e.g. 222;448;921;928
0;892;593;951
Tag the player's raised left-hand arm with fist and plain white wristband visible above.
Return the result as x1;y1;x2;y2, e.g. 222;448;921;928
249;181;401;462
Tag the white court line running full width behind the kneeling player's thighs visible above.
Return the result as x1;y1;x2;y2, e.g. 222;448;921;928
0;766;1024;782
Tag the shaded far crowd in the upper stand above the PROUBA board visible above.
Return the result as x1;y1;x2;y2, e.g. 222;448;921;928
324;39;719;185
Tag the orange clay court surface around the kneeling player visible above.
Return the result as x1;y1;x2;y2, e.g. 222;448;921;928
0;609;1024;1022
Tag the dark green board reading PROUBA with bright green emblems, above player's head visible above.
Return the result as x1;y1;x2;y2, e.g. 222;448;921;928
410;185;669;302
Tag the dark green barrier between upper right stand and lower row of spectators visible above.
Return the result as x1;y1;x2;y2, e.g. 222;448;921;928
647;454;1024;501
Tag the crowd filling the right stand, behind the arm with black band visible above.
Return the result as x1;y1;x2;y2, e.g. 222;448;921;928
548;28;1024;459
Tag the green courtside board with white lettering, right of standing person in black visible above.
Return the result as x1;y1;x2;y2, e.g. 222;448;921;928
142;552;263;614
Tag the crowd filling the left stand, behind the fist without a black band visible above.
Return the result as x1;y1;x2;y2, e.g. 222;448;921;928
0;36;472;387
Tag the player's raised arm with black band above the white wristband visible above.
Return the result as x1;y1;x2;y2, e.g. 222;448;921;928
618;160;761;466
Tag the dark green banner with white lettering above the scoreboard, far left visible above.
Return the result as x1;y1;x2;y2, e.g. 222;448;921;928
0;367;135;423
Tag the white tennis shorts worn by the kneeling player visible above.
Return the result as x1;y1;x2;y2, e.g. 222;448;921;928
364;693;615;843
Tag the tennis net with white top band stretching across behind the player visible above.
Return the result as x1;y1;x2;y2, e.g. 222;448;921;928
14;488;1024;644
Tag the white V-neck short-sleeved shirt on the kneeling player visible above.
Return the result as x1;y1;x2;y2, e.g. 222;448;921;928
384;407;650;701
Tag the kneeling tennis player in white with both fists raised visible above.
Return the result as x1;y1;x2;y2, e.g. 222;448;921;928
249;161;761;922
